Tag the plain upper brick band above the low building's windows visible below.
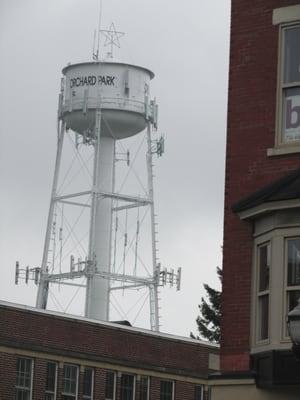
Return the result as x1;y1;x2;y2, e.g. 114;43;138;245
0;305;218;377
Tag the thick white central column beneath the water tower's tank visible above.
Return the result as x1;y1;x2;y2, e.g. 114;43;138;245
85;111;115;320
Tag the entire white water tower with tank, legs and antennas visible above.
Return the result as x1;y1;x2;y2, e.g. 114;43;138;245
16;25;180;330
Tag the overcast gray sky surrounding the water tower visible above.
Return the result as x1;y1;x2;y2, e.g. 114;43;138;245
0;0;230;335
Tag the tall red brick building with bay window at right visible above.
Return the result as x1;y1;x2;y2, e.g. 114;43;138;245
209;0;300;399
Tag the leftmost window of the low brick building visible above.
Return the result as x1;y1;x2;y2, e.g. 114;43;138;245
16;357;33;400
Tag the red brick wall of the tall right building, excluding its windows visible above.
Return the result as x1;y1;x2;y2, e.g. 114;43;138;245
221;0;300;371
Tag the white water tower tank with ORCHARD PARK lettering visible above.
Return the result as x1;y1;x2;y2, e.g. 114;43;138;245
62;62;154;139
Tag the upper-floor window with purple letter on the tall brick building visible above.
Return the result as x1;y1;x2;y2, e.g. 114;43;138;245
277;24;300;145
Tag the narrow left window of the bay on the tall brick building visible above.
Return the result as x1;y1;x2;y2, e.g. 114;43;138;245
257;242;271;341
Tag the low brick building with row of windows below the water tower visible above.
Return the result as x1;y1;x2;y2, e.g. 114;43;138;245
0;302;219;400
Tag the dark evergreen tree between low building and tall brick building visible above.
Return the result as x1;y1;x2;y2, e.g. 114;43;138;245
190;267;222;343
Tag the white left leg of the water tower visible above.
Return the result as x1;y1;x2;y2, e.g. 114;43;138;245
36;122;65;309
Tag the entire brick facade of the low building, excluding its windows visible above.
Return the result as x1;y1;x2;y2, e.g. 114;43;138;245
0;303;218;400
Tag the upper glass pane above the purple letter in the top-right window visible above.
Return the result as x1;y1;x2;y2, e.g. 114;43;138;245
284;27;300;83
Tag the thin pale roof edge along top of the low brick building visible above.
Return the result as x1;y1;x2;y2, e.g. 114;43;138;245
0;300;220;349
